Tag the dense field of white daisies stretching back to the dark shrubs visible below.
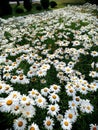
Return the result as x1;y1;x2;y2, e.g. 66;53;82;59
0;4;98;130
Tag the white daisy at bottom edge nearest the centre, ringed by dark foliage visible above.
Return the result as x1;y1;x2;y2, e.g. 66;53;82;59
44;117;54;130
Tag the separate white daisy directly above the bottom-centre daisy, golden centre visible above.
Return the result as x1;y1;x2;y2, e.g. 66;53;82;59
47;104;60;116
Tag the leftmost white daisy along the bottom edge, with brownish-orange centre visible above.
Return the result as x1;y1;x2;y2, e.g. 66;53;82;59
13;117;27;130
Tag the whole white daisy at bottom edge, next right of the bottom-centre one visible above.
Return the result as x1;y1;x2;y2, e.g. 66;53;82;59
61;118;72;130
